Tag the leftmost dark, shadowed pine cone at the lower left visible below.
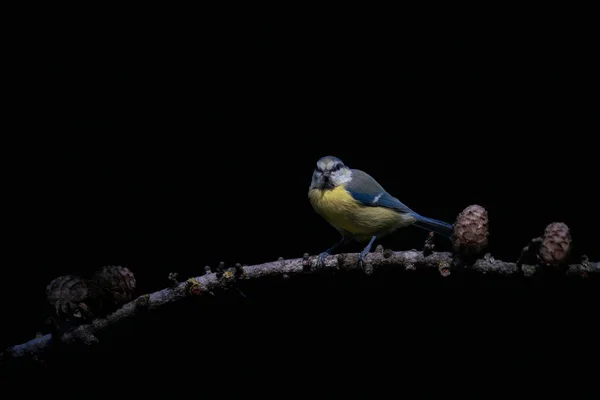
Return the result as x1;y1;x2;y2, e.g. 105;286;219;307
46;275;103;322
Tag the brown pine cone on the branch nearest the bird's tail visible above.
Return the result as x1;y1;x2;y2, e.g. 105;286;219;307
451;204;489;255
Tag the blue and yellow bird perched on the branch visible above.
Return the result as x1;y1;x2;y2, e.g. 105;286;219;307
308;156;452;267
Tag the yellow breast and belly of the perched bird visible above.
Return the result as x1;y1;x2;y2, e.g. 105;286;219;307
308;186;412;240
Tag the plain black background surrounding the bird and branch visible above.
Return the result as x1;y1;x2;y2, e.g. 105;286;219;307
0;7;600;396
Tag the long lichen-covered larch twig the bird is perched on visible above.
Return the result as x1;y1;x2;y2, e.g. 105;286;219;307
0;248;600;359
